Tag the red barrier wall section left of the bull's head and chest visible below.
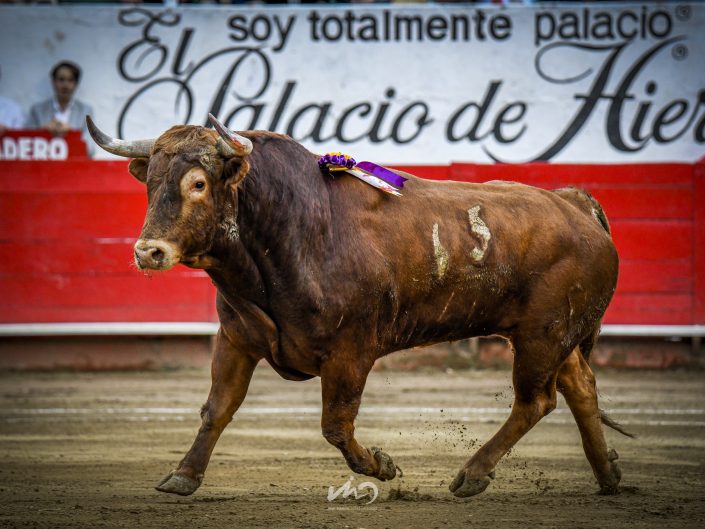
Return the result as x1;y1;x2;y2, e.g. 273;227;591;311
0;160;216;323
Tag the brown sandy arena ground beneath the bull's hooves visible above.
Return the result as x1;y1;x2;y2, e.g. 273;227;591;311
0;366;705;529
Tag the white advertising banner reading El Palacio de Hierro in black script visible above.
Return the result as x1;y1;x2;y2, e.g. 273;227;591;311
0;3;705;164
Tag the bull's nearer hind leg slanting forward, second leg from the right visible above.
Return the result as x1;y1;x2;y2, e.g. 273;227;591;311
449;337;568;497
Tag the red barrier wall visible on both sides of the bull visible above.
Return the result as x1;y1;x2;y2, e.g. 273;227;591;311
0;161;705;324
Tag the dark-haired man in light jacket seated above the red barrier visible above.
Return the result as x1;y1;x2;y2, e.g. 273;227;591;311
26;61;93;154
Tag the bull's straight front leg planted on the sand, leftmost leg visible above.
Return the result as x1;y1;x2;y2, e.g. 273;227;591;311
156;329;258;496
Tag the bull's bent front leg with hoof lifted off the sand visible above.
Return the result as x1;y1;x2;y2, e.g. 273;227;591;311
321;357;396;481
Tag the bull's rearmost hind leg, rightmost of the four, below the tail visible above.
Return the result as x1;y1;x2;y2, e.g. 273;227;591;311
557;348;622;494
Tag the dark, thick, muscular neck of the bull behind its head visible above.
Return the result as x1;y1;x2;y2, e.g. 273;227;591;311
211;137;332;308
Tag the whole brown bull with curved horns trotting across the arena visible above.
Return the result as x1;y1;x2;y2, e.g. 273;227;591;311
88;118;620;497
